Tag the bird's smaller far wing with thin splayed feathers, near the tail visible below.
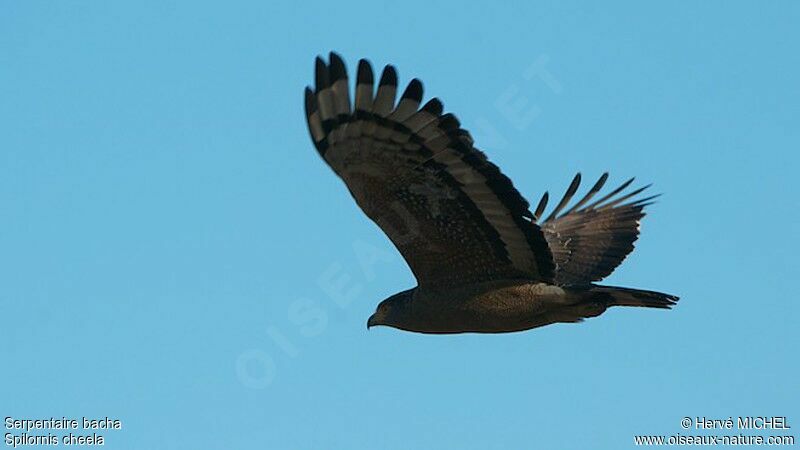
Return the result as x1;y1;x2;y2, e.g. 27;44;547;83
534;173;657;285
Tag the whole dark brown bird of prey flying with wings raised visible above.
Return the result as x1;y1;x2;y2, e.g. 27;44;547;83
305;53;678;334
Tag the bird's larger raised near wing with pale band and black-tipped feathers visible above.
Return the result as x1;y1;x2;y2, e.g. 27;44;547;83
306;53;554;288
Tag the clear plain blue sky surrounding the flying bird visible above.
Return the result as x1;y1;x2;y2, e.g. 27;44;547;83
0;1;800;449
